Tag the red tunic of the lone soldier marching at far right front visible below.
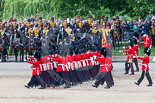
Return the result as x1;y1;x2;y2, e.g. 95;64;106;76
137;56;150;71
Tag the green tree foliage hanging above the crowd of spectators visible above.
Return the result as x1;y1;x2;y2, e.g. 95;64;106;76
0;0;155;18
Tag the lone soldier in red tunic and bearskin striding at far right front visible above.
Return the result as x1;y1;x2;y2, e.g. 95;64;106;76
135;47;153;86
